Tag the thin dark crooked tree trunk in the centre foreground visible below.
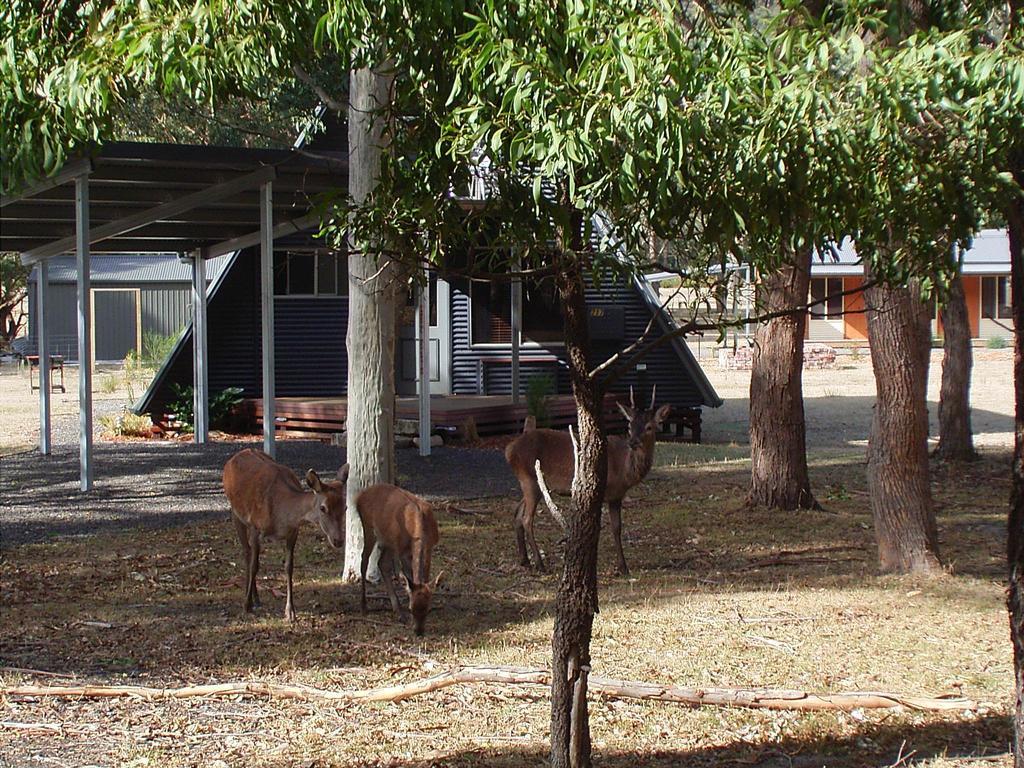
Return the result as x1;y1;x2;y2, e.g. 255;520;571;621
551;214;607;768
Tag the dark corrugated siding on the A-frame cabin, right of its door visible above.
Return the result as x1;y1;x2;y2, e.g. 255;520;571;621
452;276;702;408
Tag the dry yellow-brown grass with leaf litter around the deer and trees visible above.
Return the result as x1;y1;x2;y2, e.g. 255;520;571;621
0;445;1012;767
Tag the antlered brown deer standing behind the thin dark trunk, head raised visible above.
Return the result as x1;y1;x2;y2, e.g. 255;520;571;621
505;388;672;575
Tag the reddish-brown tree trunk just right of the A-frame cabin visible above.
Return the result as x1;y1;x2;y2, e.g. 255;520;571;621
748;247;818;509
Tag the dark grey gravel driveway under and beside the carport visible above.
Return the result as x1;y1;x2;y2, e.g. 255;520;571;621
0;440;518;549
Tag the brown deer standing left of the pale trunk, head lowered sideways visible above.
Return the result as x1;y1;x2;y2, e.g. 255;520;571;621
224;449;348;622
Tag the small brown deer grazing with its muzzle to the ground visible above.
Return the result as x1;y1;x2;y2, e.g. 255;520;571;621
355;484;443;635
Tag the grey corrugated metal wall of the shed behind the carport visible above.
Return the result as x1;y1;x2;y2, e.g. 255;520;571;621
29;283;191;361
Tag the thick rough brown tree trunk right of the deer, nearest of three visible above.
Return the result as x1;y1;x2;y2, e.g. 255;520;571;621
864;270;942;572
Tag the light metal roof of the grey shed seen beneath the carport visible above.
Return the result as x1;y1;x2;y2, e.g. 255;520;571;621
29;253;228;285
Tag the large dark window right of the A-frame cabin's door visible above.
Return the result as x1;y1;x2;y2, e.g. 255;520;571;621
470;280;562;344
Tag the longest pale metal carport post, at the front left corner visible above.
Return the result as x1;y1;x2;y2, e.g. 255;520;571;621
75;175;92;490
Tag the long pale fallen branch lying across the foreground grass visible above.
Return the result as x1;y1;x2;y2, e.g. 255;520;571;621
0;667;979;712
